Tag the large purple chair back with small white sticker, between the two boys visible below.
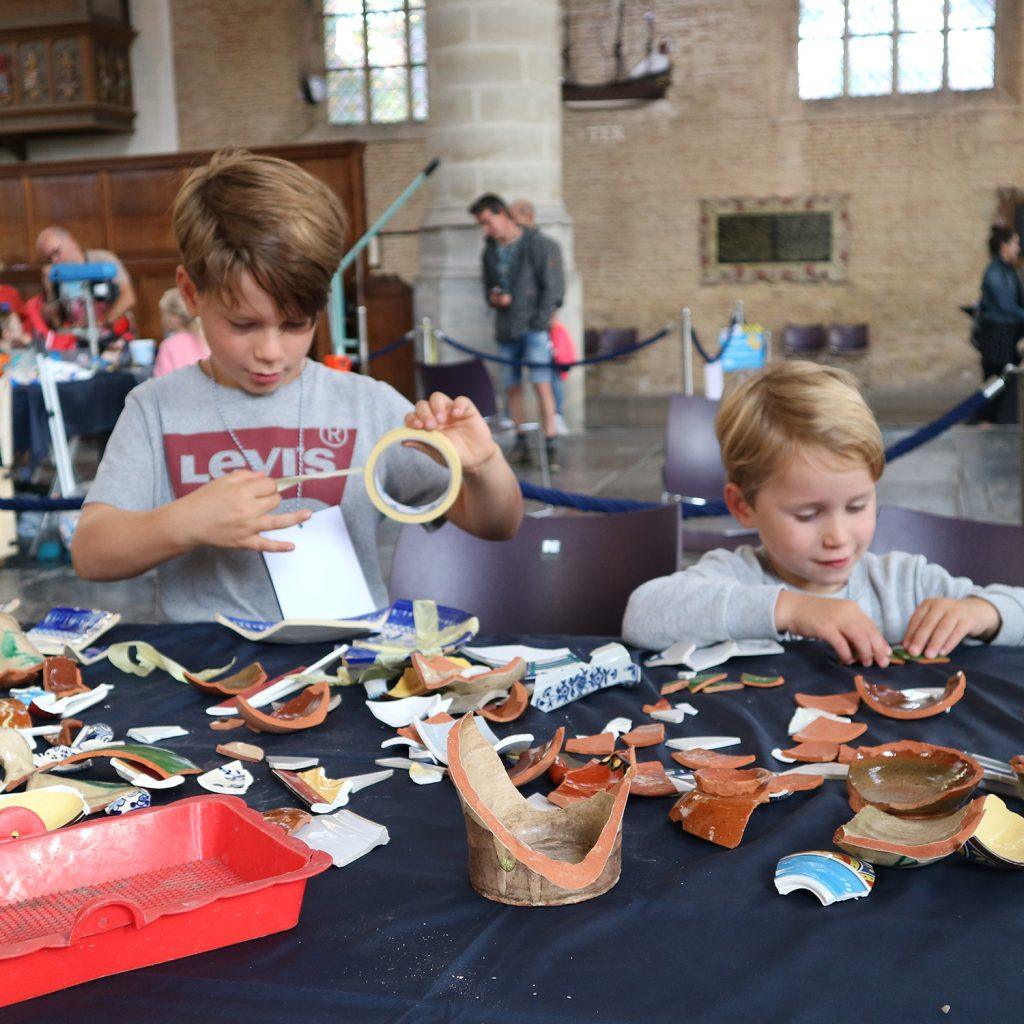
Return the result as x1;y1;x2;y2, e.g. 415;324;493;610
388;505;679;636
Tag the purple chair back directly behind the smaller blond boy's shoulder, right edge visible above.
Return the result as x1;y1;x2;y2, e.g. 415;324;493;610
871;505;1024;587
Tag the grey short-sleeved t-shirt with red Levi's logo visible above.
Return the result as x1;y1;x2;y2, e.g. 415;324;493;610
86;360;447;622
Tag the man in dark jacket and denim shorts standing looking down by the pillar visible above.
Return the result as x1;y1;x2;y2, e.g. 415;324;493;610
469;193;564;468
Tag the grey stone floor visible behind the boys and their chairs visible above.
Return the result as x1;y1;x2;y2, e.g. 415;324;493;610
0;402;1021;622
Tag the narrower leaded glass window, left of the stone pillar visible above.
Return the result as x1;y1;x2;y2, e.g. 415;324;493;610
323;0;427;125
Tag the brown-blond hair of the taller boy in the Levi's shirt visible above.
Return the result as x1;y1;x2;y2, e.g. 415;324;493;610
172;150;345;319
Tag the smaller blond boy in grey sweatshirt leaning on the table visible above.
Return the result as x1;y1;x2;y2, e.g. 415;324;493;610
623;361;1024;666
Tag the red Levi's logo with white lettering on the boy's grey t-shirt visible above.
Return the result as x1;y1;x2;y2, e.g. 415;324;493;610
164;427;355;505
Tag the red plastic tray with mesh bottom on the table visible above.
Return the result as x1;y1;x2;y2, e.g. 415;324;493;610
0;796;331;1006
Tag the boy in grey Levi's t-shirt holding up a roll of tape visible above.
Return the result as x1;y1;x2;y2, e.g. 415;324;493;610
72;152;522;622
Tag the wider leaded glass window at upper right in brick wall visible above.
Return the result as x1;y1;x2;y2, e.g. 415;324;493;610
797;0;996;99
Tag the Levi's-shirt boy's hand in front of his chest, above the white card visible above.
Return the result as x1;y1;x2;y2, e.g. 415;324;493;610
173;469;311;551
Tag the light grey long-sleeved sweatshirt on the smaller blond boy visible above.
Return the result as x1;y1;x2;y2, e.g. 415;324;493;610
623;546;1024;650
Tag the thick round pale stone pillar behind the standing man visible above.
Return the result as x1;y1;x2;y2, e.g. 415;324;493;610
416;0;585;426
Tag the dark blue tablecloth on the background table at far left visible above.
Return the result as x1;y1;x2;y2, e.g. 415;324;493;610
12;370;138;466
